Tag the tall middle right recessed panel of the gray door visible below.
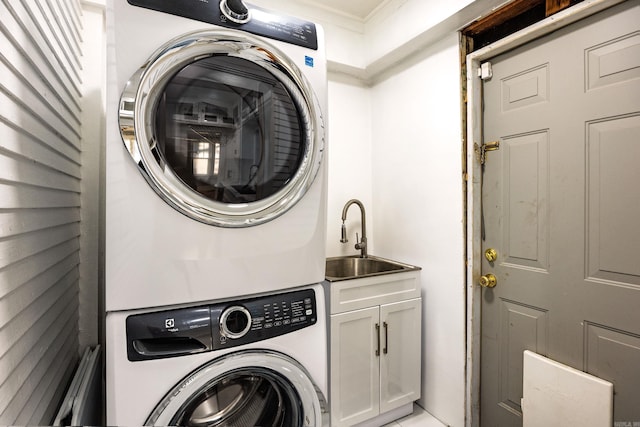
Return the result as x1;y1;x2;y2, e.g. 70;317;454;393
587;115;640;286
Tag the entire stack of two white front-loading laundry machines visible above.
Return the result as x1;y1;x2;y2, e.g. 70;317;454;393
105;0;328;427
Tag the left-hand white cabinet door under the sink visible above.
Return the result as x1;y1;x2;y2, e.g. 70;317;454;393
331;306;380;426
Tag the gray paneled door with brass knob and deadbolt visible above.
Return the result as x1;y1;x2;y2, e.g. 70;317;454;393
480;0;640;427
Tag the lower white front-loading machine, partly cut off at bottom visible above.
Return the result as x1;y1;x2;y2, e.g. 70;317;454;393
107;285;329;427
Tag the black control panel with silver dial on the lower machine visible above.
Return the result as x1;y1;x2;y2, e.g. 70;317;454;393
126;289;318;361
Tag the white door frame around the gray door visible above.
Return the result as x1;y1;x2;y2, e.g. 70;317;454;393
463;0;625;427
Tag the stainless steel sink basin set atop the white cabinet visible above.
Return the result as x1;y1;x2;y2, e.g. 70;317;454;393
325;256;420;282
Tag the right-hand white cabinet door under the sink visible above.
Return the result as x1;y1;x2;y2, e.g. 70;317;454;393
380;298;422;412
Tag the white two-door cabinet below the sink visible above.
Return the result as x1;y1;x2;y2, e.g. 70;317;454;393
329;271;422;427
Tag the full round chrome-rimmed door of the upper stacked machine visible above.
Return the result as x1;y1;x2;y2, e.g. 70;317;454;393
119;30;324;227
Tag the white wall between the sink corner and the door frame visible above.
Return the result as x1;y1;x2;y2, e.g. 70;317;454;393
370;33;465;426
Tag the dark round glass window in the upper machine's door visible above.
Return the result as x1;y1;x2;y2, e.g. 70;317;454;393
156;56;305;203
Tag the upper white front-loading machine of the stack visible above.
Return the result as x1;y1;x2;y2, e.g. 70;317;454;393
105;0;327;312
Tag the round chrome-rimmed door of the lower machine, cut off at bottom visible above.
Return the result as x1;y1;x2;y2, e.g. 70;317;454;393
145;350;328;427
